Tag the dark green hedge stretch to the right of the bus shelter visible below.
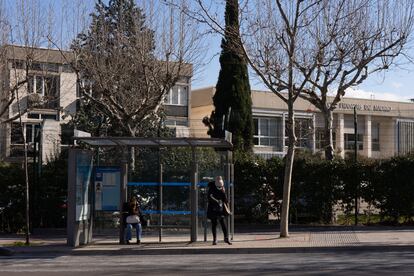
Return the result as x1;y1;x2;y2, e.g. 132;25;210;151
234;154;414;223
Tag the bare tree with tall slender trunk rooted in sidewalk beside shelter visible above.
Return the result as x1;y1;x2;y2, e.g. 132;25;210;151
190;0;321;237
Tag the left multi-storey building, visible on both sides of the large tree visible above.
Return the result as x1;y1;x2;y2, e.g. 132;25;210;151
0;45;192;162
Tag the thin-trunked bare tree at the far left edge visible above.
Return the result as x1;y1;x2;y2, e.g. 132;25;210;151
0;0;61;244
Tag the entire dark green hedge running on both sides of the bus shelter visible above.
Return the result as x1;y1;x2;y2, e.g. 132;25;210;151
0;152;414;232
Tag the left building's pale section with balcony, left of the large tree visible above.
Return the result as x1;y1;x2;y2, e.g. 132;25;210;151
0;45;77;162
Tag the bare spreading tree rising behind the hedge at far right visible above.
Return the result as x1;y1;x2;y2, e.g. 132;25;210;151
295;0;414;159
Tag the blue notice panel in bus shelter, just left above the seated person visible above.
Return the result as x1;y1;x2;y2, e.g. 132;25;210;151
95;167;121;211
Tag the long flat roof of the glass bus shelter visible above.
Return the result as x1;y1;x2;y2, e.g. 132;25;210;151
74;137;233;150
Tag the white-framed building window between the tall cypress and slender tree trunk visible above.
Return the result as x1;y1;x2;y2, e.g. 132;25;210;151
253;117;283;151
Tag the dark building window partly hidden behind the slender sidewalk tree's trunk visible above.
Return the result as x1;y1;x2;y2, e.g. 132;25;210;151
285;118;313;149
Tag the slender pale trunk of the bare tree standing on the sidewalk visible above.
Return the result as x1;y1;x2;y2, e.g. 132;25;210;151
280;101;296;238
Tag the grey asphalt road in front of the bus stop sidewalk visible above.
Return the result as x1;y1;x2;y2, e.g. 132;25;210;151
0;250;414;276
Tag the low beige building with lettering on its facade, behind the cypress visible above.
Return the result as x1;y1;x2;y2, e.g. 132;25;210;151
191;87;414;158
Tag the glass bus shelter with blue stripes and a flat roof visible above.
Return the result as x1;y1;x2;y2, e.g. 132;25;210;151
67;137;234;247
